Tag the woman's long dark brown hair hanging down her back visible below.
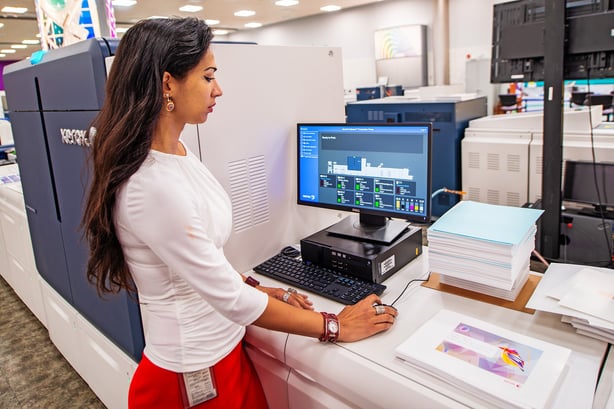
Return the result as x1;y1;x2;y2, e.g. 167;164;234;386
81;18;213;295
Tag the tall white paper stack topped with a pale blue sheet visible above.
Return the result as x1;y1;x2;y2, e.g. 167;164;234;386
427;201;543;300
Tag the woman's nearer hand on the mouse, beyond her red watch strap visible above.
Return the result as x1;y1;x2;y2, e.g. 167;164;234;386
337;294;397;342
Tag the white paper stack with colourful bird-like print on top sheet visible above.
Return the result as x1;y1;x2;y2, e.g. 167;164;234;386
395;310;571;408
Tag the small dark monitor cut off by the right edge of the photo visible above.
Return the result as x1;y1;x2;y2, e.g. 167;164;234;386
563;160;614;207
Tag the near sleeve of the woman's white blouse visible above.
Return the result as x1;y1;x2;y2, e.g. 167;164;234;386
120;163;268;325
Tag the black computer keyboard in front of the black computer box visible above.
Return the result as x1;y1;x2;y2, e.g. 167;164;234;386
254;254;386;305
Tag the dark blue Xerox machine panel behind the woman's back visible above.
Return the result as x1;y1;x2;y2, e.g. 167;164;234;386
4;39;144;361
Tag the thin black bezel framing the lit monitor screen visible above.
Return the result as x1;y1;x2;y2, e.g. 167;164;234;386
296;122;433;224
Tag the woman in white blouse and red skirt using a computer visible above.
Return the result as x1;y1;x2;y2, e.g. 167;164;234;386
83;18;396;409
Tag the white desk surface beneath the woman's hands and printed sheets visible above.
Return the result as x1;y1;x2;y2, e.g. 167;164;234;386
247;248;607;409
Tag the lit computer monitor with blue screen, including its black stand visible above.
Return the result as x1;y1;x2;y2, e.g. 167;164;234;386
297;123;432;243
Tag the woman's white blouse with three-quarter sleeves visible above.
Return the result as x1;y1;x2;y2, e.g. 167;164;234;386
115;142;268;372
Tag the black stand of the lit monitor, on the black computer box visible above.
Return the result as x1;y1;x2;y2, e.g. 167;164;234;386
326;214;409;244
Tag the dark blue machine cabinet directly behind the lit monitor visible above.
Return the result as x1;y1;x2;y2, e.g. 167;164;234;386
346;97;487;216
